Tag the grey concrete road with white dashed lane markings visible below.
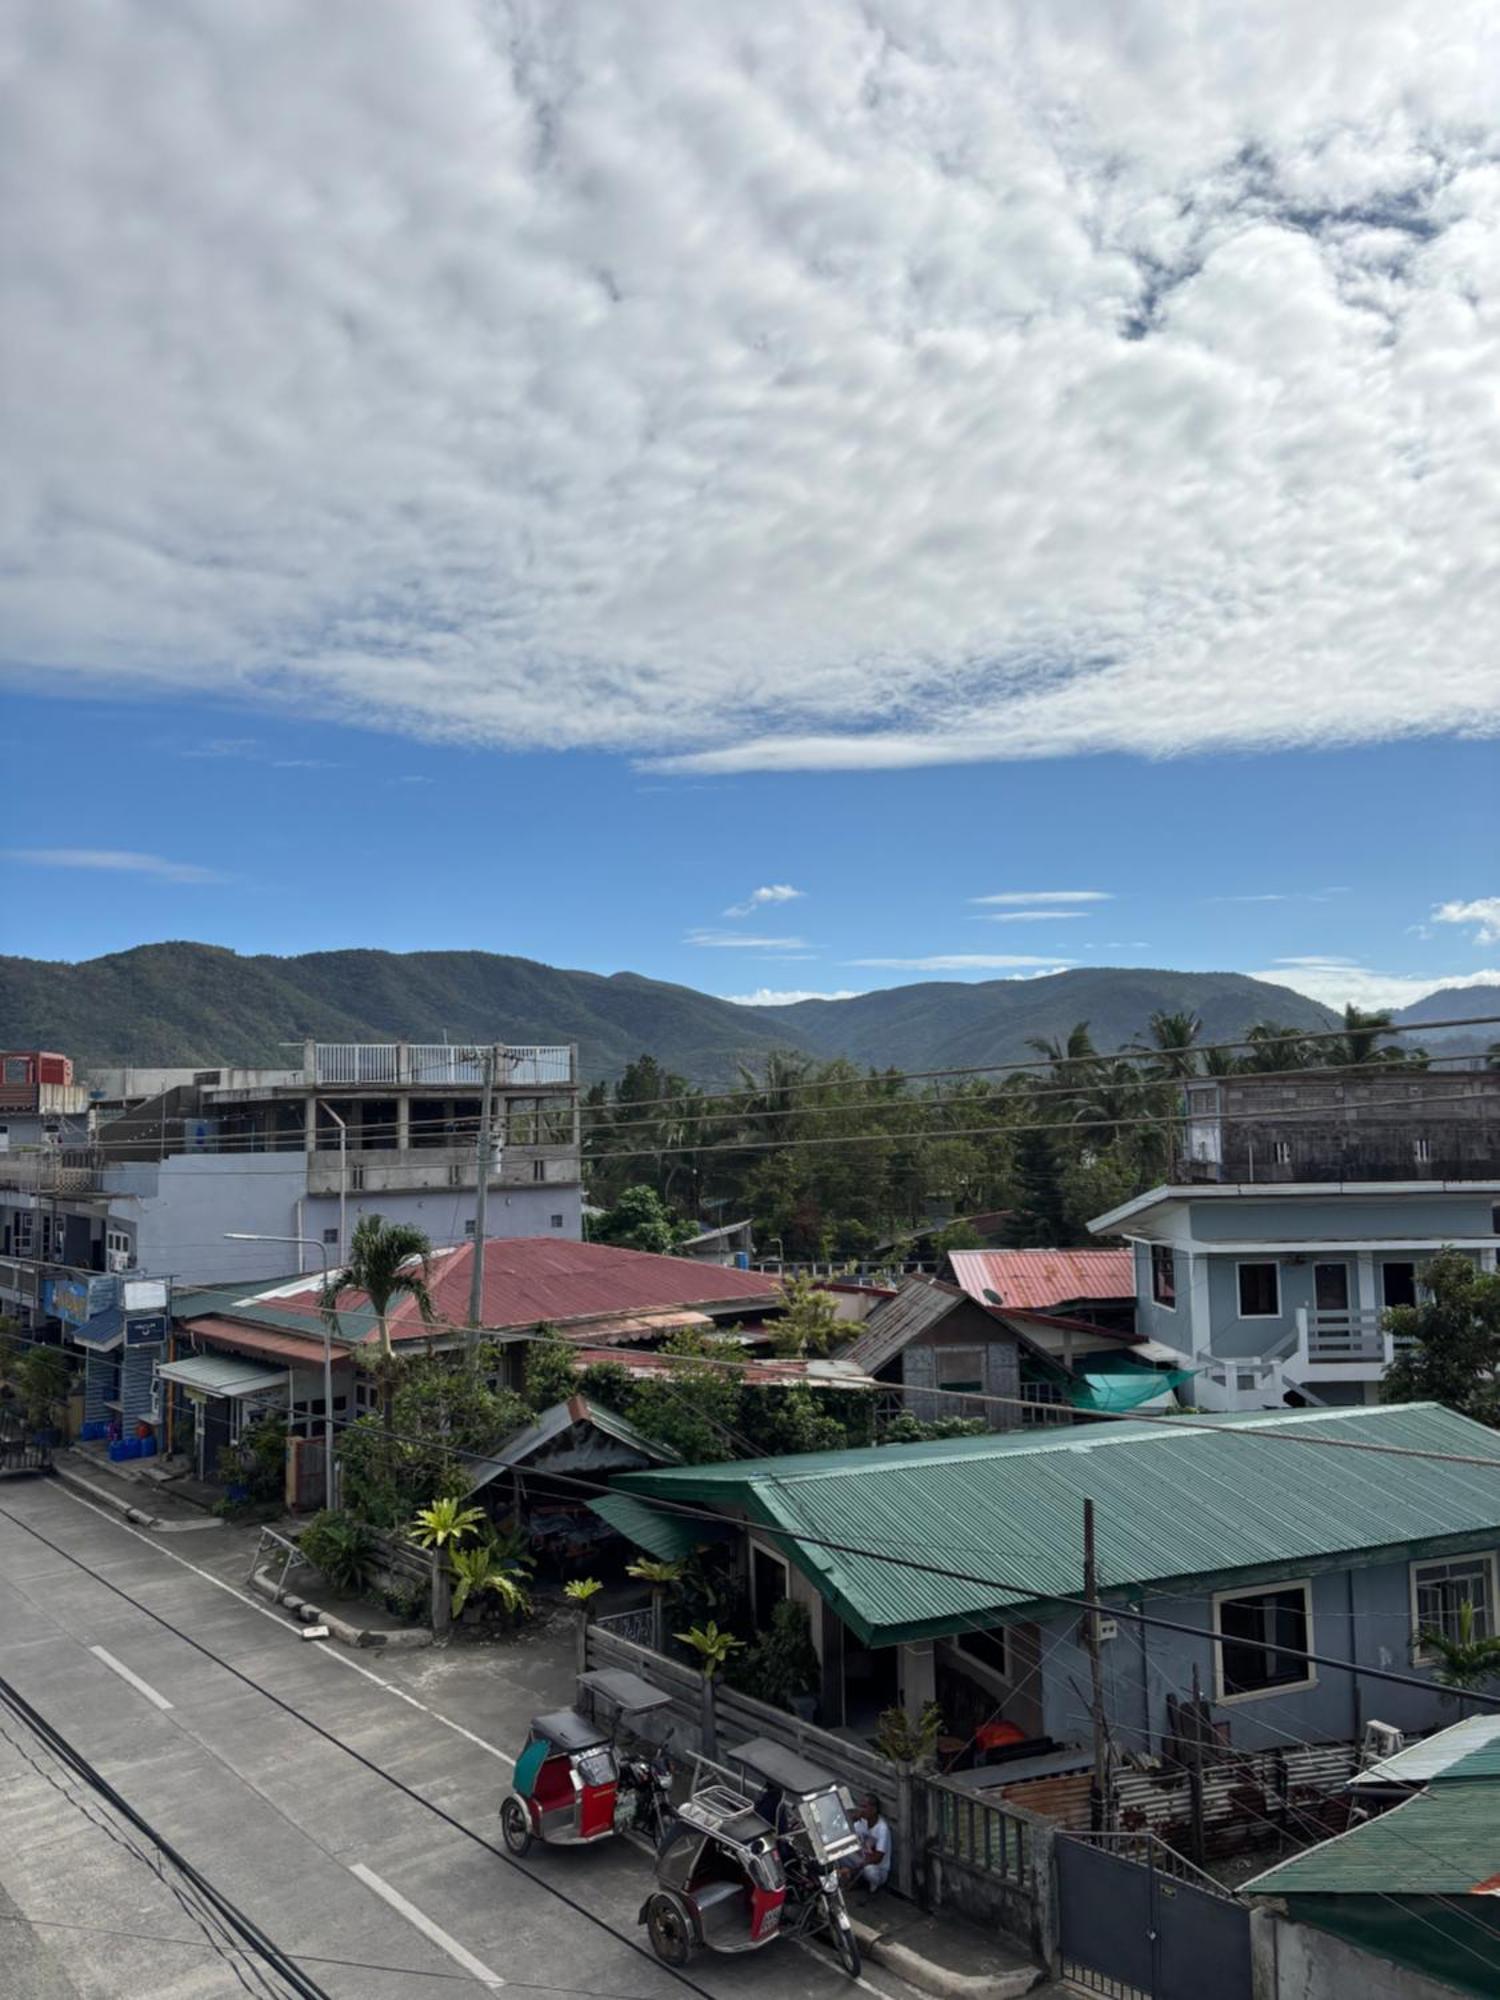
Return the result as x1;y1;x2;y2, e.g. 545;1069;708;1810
0;1480;936;2000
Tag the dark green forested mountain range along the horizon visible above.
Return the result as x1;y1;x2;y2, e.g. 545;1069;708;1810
0;944;1500;1084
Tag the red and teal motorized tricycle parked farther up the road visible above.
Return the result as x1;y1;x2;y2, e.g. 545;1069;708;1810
500;1668;672;1856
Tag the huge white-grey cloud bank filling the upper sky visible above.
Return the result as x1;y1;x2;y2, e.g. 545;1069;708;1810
0;0;1500;770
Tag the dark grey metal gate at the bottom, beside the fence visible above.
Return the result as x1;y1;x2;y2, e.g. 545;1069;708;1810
1056;1834;1250;2000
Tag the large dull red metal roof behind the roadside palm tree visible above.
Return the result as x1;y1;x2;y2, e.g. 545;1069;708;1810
223;1236;782;1340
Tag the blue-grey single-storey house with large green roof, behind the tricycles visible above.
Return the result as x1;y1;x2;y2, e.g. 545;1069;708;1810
594;1404;1500;1768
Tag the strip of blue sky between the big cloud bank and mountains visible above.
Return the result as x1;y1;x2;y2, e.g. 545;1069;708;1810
6;698;1500;1000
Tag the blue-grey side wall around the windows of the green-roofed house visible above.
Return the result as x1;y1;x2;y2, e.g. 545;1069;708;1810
1042;1562;1496;1754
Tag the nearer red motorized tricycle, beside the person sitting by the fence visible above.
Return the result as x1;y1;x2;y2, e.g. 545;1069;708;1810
640;1736;860;1978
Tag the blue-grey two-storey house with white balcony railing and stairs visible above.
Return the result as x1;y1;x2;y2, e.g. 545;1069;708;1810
1088;1180;1500;1410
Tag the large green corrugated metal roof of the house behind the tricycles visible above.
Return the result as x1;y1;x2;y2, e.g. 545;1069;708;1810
614;1404;1500;1644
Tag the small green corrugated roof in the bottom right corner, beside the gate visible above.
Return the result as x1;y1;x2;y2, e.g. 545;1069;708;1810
1244;1778;1500;1896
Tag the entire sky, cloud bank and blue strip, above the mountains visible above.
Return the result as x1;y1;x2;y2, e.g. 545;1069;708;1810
0;0;1500;1004
